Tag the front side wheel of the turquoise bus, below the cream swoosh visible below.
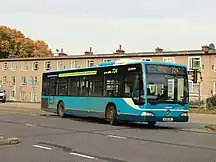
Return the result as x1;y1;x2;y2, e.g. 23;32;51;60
106;105;118;125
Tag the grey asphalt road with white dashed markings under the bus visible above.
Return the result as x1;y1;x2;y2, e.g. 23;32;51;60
0;104;216;162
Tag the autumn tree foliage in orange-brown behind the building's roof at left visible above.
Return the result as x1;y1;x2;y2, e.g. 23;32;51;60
0;26;53;57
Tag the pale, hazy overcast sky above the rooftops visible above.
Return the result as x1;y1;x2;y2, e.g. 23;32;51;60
0;0;216;54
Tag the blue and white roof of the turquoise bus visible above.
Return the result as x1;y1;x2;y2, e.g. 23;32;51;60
44;59;187;74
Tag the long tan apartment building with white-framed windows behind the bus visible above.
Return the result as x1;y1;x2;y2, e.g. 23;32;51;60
0;46;216;102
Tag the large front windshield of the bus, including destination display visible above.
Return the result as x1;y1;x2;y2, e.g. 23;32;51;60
146;65;188;104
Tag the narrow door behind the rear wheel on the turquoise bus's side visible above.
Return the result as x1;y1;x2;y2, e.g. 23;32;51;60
48;78;56;108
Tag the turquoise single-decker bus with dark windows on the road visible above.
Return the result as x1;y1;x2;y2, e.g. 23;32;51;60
41;59;189;126
